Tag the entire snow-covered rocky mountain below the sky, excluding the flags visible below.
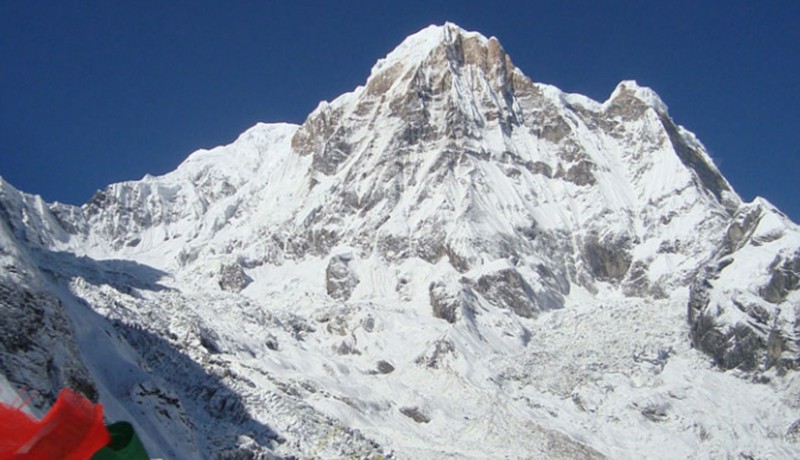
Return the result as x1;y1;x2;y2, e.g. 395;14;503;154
0;24;800;458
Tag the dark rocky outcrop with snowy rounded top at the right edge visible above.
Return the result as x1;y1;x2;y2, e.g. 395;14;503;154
688;202;800;372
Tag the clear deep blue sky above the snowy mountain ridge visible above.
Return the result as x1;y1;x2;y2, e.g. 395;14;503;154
0;0;800;222
